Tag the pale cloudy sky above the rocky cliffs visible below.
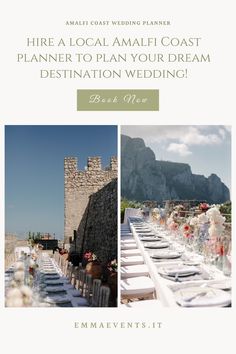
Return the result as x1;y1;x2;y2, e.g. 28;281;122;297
121;125;231;189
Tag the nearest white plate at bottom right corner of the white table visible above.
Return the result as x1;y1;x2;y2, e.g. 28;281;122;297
175;287;231;307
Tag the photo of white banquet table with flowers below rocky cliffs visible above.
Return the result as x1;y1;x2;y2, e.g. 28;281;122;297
120;125;232;309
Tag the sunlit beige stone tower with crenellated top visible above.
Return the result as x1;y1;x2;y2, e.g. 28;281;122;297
64;157;118;248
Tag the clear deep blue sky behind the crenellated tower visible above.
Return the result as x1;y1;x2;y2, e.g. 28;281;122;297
5;125;117;238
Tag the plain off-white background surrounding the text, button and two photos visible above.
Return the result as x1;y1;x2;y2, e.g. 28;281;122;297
0;0;235;354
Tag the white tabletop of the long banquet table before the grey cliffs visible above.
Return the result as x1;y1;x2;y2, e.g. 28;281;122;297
128;218;231;307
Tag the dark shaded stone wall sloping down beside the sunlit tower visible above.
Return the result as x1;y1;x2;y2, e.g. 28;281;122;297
76;179;117;262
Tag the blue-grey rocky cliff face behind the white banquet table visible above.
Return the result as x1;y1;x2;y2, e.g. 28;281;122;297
121;135;230;203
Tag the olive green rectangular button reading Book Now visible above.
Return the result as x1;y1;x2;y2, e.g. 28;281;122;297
77;90;159;111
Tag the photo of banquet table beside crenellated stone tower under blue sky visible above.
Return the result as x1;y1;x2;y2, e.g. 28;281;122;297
5;125;118;307
